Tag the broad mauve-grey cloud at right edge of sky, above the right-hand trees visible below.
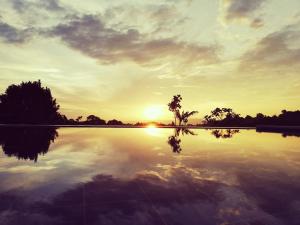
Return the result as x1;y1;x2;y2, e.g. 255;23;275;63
240;24;300;70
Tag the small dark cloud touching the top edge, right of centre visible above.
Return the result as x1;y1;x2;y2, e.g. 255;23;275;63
224;0;266;21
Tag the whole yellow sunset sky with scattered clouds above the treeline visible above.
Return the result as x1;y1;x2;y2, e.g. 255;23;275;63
0;0;300;122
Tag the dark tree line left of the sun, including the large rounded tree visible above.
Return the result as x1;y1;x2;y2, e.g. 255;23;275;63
0;80;123;125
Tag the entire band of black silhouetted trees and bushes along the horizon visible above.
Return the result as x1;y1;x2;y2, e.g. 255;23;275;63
0;81;300;127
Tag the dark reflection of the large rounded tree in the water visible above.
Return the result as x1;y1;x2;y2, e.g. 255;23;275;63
0;127;58;162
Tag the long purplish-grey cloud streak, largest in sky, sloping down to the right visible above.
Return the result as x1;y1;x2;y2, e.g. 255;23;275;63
45;15;218;64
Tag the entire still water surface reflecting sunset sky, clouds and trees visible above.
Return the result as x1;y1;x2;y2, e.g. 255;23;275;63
0;128;300;225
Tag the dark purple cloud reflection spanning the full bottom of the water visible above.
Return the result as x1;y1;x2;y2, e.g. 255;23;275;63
0;163;299;225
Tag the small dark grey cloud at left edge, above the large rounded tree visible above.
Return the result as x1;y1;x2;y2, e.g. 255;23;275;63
0;21;32;44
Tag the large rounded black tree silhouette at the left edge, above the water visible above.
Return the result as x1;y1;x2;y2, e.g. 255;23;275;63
0;81;61;124
